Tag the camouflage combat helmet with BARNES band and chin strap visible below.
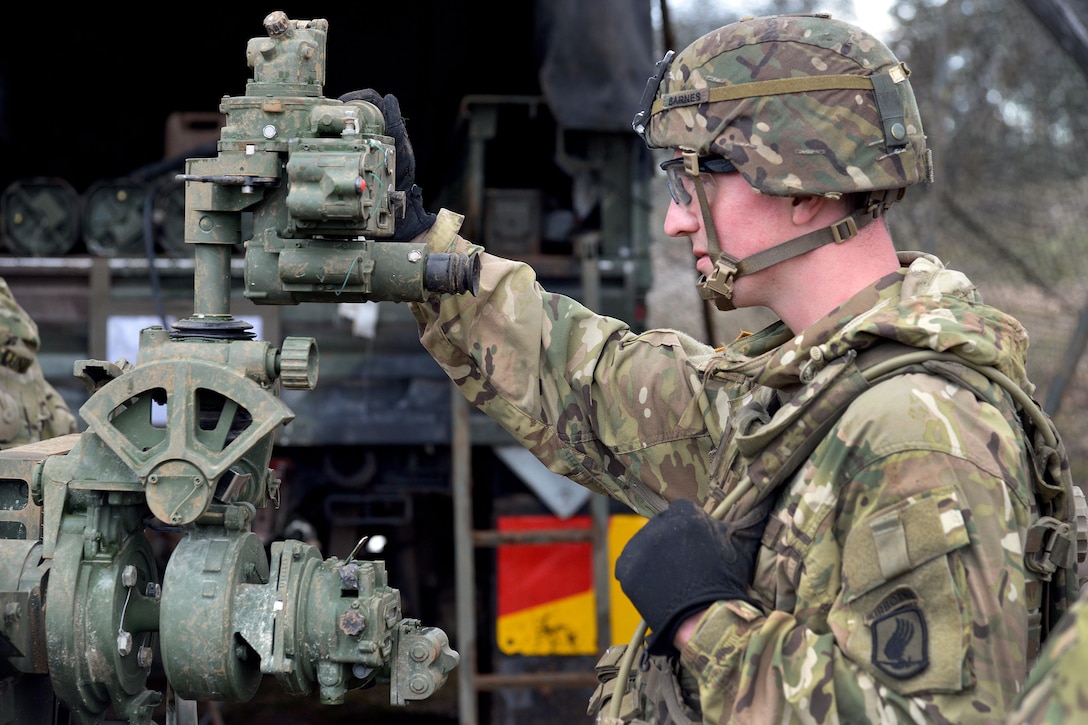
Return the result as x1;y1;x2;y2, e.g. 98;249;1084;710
632;14;932;309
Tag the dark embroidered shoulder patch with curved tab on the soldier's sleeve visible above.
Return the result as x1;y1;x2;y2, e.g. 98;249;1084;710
867;588;929;679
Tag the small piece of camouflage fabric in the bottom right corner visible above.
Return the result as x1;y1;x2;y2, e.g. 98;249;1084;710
1009;591;1088;725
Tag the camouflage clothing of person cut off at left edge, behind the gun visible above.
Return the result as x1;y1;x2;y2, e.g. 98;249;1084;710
0;279;77;448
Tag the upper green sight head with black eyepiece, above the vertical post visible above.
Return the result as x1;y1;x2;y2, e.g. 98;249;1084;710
181;13;479;305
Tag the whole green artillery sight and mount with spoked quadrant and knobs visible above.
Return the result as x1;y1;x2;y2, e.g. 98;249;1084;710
0;12;463;725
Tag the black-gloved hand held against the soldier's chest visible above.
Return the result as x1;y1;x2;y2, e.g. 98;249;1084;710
616;497;771;654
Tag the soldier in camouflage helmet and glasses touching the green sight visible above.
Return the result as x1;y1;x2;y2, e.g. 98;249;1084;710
345;15;1072;723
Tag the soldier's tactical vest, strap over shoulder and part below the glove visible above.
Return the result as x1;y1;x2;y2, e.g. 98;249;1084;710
589;342;1088;725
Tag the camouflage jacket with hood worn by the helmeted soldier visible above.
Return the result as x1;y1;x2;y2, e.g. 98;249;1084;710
413;211;1038;724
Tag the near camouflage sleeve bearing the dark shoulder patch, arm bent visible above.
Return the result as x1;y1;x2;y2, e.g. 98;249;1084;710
681;376;1031;723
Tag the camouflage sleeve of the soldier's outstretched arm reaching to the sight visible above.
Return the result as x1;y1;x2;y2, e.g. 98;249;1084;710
412;210;728;516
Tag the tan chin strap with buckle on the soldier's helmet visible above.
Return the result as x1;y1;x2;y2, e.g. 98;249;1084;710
684;163;906;311
